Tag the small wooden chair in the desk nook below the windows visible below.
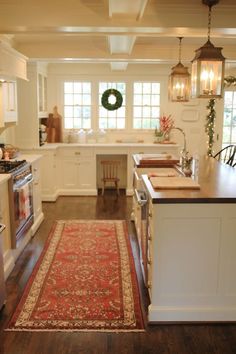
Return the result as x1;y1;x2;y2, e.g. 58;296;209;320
101;160;120;195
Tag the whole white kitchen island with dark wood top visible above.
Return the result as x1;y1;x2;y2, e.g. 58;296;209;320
142;158;236;322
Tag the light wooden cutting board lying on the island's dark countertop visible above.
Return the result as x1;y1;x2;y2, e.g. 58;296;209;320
150;177;200;189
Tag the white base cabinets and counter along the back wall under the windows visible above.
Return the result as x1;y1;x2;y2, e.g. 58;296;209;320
24;144;178;201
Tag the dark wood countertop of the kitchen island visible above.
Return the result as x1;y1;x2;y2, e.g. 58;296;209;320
142;157;236;204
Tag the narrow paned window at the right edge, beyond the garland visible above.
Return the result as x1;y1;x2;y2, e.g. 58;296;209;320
222;91;236;147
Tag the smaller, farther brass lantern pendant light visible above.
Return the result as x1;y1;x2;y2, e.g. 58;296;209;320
169;37;190;102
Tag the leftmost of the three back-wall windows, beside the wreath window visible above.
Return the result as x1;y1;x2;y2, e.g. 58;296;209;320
64;81;91;129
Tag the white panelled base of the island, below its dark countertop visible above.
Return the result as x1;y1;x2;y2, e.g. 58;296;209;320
148;203;236;322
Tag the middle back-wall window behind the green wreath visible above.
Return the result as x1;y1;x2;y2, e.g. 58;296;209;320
99;82;126;129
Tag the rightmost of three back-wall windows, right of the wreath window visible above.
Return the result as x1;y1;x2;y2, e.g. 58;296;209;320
133;82;160;129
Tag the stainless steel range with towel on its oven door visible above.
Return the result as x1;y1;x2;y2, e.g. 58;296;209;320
0;160;33;248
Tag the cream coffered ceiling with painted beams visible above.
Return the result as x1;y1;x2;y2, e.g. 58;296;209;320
0;0;236;70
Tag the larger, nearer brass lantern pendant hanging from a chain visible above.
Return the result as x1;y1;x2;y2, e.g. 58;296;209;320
191;0;225;99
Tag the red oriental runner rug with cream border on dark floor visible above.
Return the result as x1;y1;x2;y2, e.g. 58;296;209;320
7;220;144;332
